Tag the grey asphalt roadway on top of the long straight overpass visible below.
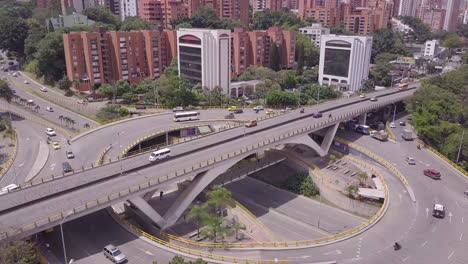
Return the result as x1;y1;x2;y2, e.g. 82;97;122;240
0;87;413;236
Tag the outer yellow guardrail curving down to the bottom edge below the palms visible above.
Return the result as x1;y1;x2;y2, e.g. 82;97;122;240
119;214;290;264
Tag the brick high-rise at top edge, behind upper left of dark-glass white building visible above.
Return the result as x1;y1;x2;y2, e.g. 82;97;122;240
297;0;341;27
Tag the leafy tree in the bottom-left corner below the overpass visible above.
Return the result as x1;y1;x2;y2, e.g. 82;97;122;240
0;241;38;264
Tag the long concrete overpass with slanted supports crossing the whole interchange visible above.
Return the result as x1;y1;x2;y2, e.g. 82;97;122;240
0;89;414;240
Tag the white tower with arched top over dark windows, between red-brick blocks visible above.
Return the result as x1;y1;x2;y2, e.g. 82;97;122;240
177;28;231;94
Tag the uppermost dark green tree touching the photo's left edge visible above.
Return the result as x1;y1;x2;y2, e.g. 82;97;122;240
0;15;28;56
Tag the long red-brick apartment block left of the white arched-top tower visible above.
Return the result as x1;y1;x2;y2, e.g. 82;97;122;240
63;28;172;92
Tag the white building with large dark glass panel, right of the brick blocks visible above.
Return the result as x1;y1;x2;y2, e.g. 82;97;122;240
319;35;372;91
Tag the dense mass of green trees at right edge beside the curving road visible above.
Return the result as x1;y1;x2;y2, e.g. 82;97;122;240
406;65;468;169
